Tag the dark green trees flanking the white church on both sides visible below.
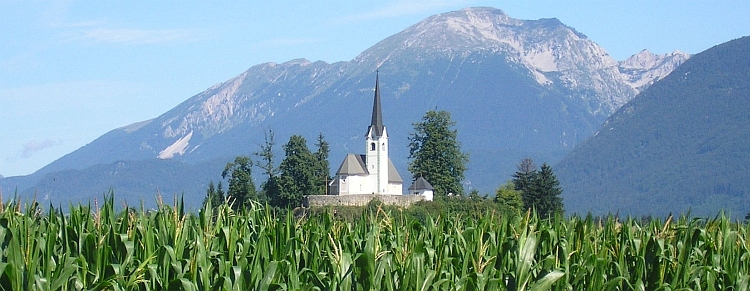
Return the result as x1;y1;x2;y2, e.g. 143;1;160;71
204;110;563;217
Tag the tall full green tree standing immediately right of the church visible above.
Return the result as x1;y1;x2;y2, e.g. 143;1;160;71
409;110;469;197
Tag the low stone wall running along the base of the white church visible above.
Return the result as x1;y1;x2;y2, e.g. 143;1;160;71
302;194;424;207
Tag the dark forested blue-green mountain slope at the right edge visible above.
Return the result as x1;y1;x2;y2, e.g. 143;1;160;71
555;37;750;217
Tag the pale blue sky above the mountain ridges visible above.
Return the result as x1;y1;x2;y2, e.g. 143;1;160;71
0;0;750;177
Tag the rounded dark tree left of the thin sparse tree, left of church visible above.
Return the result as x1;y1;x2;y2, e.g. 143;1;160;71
221;156;259;210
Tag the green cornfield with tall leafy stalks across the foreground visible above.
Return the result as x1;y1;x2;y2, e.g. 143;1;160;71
0;197;750;290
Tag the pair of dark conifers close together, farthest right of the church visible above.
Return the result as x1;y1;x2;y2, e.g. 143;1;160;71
513;159;563;217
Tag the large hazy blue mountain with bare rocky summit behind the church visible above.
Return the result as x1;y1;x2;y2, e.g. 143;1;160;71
3;8;687;208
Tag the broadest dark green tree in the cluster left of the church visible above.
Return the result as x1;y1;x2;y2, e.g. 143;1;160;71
271;135;316;207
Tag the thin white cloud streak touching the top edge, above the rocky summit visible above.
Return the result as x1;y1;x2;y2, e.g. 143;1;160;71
335;0;469;23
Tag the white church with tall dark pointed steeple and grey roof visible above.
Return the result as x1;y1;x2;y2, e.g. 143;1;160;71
329;75;432;200
